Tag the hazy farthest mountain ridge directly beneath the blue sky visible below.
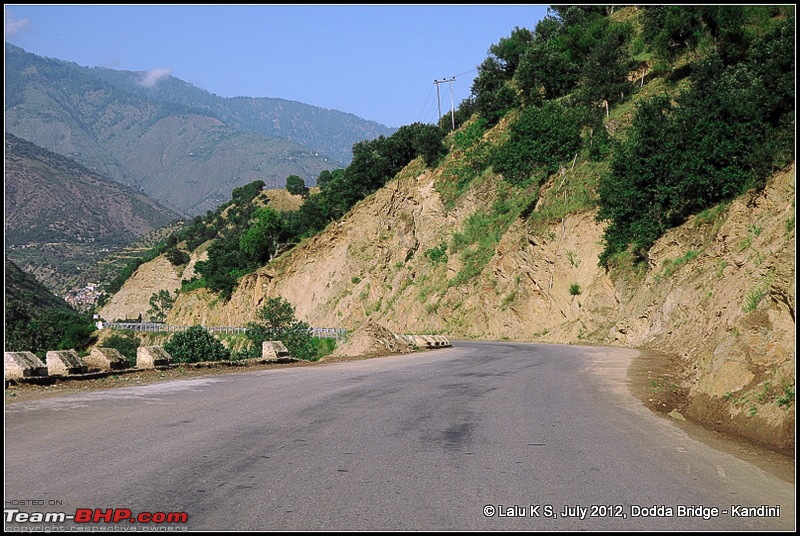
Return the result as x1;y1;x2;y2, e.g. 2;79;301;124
5;44;393;215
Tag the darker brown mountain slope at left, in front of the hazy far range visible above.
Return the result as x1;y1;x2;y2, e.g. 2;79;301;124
4;133;180;291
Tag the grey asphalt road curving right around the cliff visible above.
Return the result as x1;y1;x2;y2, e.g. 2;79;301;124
4;342;795;530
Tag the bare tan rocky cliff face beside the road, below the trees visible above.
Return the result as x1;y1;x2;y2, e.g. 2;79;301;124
114;162;795;450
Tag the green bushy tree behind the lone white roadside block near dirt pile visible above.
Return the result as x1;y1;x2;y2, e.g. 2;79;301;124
247;297;319;361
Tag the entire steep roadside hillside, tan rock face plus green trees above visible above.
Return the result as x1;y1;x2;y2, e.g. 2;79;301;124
97;6;795;451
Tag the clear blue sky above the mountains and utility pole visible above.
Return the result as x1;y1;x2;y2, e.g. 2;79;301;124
5;4;547;127
